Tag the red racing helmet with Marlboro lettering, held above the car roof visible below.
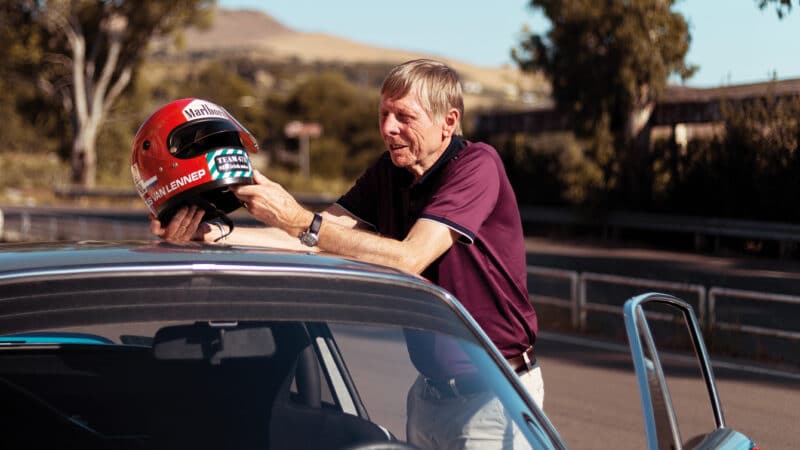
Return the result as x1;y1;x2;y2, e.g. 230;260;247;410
131;98;258;225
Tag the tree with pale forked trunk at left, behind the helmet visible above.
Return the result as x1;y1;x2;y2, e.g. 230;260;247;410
0;0;215;187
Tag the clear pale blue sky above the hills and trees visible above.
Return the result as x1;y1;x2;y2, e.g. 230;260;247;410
219;0;800;87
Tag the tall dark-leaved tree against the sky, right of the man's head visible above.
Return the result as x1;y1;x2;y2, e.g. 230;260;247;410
512;0;696;206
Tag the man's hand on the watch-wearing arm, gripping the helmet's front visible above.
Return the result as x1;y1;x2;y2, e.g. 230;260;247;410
231;170;314;236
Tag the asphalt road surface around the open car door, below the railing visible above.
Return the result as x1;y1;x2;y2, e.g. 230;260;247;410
538;332;800;449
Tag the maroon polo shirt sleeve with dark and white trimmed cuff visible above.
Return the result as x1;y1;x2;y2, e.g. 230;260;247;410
420;146;500;244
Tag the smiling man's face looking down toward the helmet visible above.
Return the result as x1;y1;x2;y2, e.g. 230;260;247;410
380;91;449;176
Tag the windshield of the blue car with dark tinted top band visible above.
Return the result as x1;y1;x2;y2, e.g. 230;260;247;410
0;268;551;449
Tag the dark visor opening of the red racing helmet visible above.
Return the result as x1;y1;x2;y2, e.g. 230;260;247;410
167;120;244;159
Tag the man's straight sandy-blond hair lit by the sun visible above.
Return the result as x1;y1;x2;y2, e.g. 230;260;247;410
381;59;464;134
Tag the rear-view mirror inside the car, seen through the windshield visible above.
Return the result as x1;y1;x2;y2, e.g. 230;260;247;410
153;322;275;365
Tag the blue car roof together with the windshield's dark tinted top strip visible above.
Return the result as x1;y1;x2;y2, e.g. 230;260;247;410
0;240;478;341
